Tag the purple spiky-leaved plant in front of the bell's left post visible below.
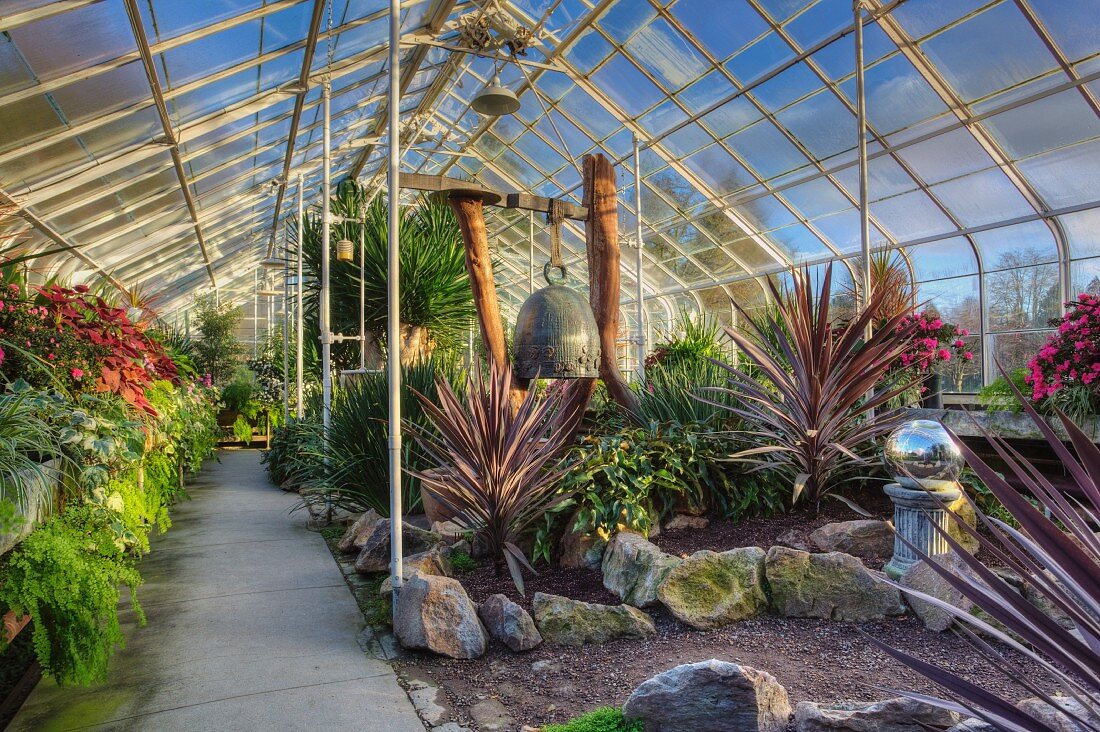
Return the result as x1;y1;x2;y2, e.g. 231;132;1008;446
407;361;582;593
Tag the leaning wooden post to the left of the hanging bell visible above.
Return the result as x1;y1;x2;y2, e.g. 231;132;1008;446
449;195;527;413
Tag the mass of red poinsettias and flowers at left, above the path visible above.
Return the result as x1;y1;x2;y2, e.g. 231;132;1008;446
0;285;178;415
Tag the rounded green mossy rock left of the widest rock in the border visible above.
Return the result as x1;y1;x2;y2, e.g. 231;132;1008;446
657;546;768;630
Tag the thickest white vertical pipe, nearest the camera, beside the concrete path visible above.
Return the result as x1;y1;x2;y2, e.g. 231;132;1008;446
386;0;404;614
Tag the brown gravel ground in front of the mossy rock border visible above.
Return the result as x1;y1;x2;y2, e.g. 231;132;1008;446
398;598;1038;729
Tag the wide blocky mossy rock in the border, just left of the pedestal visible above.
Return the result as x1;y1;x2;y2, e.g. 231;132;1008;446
765;546;905;622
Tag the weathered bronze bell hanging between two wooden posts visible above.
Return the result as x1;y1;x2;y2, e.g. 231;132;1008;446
512;262;600;379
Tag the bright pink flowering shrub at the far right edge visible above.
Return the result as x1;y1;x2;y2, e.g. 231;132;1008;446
1024;293;1100;402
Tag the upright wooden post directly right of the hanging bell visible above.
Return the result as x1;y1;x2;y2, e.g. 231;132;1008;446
584;154;640;415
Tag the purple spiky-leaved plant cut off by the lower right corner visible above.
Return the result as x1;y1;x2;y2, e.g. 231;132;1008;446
876;382;1100;732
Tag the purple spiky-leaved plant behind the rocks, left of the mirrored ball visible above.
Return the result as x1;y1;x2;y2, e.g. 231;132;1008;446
701;265;910;507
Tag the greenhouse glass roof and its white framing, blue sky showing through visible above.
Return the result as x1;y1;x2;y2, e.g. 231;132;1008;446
0;0;1100;392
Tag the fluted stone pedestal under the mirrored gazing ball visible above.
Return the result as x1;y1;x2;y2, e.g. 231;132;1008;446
883;483;961;579
